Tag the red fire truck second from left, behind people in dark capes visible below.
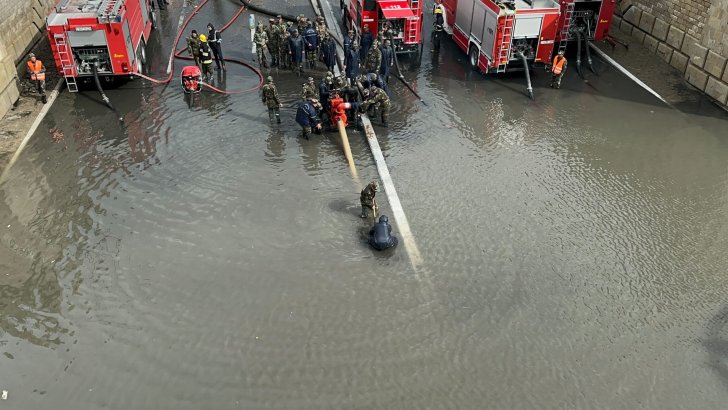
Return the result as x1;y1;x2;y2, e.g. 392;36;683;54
341;0;424;61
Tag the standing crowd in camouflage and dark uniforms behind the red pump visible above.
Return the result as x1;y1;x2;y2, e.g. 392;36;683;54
253;15;336;75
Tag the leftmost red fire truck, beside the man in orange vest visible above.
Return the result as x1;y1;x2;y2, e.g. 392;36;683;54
46;0;156;92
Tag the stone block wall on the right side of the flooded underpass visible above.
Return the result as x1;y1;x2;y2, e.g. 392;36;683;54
614;0;728;109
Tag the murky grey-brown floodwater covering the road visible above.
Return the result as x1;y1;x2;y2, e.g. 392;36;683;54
0;2;728;409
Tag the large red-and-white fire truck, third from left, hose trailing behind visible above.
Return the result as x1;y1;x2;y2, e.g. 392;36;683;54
442;0;560;73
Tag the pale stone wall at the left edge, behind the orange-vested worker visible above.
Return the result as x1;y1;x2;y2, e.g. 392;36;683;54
0;0;55;118
